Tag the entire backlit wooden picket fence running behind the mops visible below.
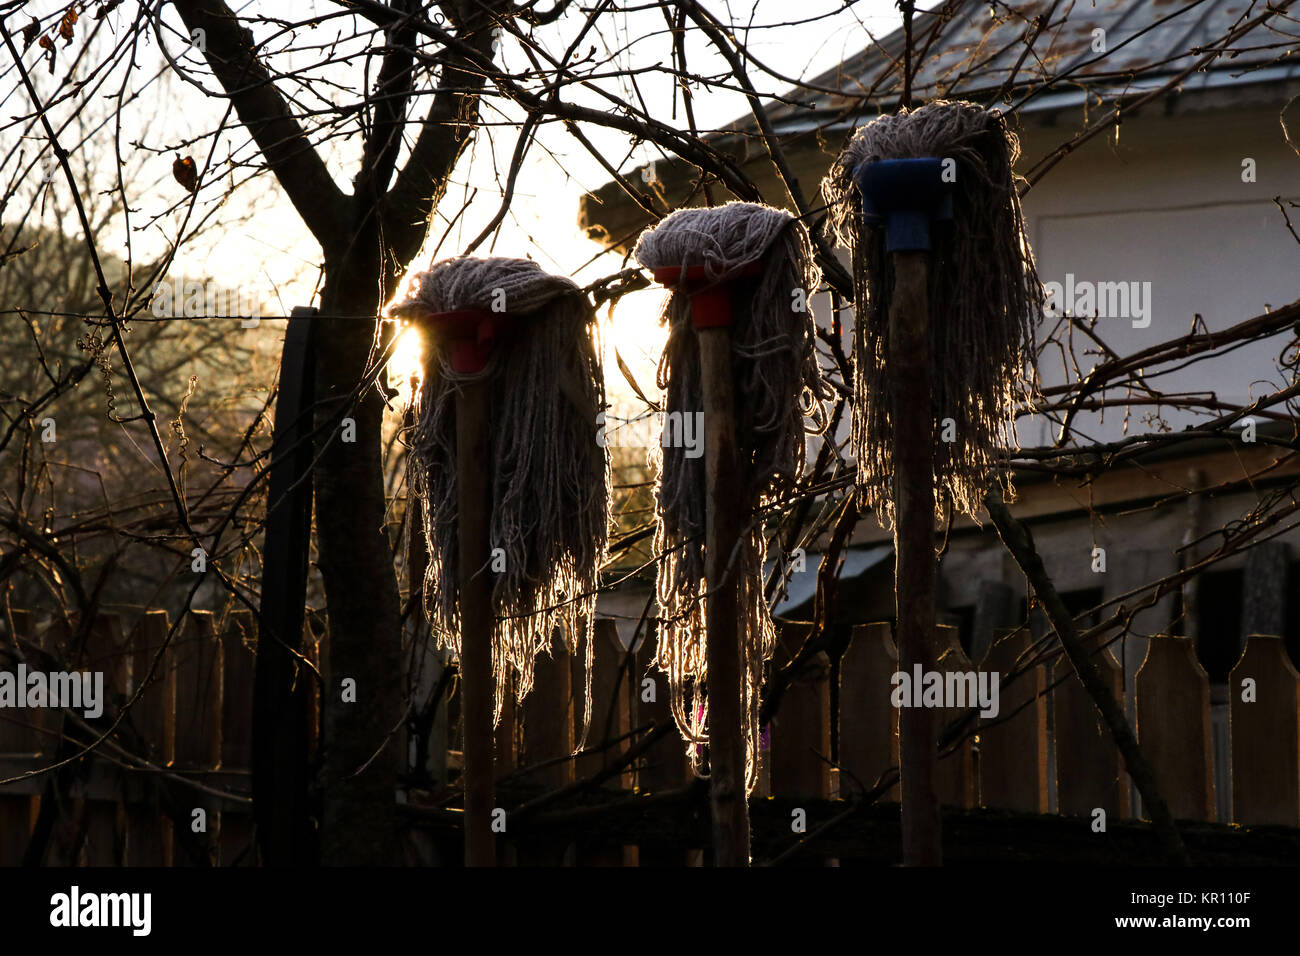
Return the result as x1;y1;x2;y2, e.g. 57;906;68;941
0;611;1300;865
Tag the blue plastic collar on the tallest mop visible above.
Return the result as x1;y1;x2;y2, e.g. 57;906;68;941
853;157;956;252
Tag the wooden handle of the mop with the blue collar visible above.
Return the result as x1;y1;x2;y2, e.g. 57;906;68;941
889;251;943;866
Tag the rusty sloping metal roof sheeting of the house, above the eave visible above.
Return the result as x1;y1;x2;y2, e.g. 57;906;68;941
759;0;1300;133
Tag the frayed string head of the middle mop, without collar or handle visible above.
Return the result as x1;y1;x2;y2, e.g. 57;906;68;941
634;203;826;790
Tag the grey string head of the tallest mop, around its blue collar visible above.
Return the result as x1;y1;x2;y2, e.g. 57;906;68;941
822;100;1044;528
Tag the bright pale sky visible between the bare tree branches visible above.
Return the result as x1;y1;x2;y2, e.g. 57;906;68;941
0;0;915;401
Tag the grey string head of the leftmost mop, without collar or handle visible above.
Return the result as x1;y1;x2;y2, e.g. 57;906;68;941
391;258;610;747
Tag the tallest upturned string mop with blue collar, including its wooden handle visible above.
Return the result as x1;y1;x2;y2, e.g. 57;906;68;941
822;101;1043;865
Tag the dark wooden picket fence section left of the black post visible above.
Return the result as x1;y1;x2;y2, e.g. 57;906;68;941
0;611;316;866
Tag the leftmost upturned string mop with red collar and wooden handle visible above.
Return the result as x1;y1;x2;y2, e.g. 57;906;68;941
390;258;610;865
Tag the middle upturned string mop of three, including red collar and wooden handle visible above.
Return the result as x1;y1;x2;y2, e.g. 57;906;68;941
634;203;824;866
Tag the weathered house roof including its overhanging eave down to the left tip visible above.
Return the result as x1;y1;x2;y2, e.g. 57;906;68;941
579;0;1300;250
